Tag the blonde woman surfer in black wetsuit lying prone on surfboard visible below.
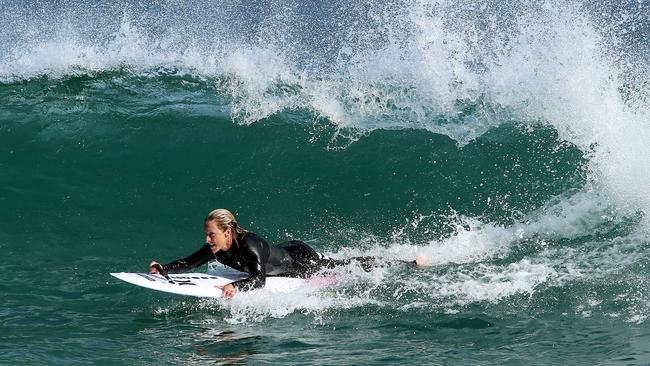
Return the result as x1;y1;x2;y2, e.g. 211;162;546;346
149;209;428;298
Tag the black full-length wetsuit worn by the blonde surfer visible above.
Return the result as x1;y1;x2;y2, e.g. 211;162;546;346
161;232;360;291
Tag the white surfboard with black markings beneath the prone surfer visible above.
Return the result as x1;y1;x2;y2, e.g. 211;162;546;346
111;272;336;298
